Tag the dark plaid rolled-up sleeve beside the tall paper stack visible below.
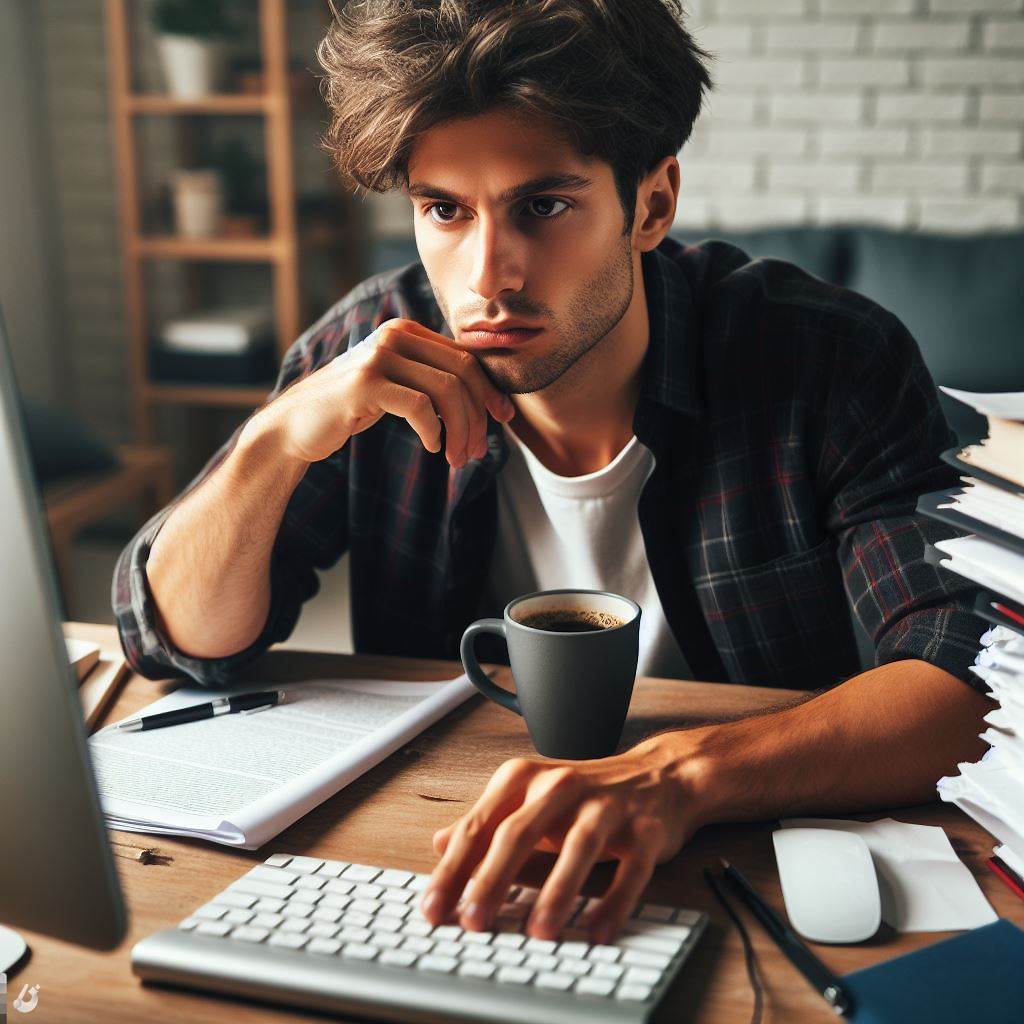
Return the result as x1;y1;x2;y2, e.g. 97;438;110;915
819;307;987;691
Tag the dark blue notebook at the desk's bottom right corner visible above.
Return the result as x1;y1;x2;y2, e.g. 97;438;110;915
843;921;1024;1024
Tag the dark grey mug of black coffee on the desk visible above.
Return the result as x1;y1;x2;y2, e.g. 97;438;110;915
462;590;640;760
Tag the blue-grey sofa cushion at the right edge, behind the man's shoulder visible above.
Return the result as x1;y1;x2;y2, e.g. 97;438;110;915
848;228;1024;443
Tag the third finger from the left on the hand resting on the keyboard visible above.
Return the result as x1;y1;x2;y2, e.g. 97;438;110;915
528;800;623;939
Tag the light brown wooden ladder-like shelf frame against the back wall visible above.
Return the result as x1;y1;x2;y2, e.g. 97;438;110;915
105;0;315;441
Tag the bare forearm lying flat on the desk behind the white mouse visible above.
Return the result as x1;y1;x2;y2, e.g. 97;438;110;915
641;660;993;824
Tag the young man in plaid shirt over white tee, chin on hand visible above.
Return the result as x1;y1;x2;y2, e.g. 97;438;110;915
115;0;989;940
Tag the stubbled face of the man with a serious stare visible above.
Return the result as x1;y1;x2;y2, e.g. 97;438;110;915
409;111;639;394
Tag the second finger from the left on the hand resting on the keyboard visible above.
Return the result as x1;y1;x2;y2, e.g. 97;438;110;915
462;768;584;930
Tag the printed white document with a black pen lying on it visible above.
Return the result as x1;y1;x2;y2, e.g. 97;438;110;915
90;676;475;849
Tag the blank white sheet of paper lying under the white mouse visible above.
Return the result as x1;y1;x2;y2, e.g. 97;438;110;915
781;818;997;932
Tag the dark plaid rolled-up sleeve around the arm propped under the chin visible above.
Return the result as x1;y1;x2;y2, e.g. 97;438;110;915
111;310;355;687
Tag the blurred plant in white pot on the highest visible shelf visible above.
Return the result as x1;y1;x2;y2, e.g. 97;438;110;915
153;0;230;99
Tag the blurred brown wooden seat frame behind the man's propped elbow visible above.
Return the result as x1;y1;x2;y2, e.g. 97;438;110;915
43;444;174;605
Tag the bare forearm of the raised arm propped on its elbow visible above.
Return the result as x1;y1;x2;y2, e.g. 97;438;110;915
146;421;306;657
